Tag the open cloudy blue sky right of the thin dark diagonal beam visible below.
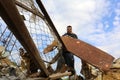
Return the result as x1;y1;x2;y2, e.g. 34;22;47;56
42;0;120;74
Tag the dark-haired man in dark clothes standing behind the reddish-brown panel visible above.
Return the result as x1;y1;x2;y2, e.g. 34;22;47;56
63;26;78;74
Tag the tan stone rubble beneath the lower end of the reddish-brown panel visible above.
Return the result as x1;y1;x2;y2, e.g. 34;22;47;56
81;58;120;80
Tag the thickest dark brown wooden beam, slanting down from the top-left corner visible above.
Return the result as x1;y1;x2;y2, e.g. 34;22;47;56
0;0;49;76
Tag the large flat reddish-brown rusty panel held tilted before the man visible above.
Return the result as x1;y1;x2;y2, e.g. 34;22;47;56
62;37;114;71
